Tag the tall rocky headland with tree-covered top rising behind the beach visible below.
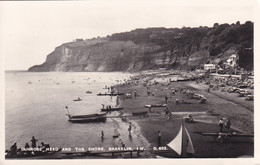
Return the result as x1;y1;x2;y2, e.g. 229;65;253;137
29;22;253;71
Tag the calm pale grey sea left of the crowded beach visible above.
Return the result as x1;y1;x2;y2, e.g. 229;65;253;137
5;71;149;150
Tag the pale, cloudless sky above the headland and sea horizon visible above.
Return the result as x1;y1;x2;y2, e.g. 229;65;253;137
0;0;259;70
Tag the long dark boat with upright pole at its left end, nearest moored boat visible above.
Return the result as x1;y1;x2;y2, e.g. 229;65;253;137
68;113;106;123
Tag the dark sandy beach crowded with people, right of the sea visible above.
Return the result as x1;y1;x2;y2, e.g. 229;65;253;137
116;71;254;158
